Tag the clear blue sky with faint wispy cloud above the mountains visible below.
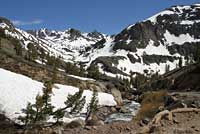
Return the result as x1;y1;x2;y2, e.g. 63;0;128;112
0;0;200;34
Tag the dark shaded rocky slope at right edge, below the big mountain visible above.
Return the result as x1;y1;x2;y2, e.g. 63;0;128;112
141;63;200;92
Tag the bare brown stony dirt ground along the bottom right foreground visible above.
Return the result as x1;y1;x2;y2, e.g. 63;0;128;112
64;112;200;134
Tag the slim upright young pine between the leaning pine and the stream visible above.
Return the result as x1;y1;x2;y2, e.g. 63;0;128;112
85;91;99;122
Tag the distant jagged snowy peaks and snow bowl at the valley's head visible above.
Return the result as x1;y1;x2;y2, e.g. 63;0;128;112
27;28;108;62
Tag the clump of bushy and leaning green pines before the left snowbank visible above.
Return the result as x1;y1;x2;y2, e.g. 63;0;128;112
18;81;86;127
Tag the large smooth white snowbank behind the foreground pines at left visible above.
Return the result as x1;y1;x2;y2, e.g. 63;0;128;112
0;68;116;120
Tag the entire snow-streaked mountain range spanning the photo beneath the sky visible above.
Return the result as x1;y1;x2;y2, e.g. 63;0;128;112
0;4;200;77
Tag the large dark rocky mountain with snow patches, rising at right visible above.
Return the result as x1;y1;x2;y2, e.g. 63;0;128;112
82;4;200;76
